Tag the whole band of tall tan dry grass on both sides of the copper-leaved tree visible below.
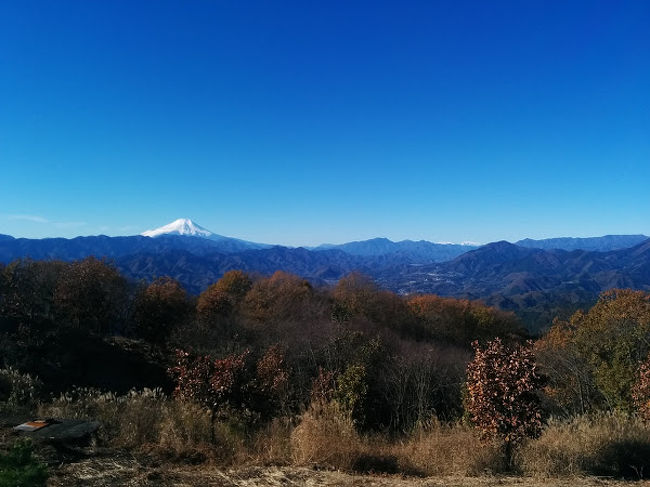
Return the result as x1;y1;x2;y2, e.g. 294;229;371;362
39;389;650;478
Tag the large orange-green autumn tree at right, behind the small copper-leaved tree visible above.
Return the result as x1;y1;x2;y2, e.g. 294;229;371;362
536;289;650;413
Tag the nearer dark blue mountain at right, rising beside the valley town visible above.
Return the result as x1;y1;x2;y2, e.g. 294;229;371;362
375;239;650;329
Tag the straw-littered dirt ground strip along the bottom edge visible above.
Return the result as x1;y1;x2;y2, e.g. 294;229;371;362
48;458;650;487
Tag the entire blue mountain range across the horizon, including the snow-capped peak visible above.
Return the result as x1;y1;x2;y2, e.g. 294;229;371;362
0;219;650;334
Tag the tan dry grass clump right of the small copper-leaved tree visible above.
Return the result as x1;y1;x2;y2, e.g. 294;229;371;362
519;413;650;479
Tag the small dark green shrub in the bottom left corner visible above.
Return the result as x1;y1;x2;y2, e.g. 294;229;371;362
0;441;48;487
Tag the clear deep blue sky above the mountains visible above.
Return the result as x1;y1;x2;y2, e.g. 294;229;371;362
0;0;650;245
